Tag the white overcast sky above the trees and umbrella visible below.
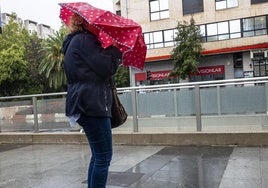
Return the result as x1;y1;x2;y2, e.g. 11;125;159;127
0;0;113;30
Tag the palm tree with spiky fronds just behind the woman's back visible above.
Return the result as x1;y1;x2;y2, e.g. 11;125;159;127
39;27;66;89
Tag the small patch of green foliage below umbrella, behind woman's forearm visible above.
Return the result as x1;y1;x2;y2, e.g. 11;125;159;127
114;66;129;87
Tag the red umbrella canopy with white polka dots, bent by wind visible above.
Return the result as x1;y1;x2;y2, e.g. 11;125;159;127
59;2;147;70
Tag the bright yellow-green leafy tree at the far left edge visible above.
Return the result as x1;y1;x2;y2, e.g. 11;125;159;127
0;15;30;95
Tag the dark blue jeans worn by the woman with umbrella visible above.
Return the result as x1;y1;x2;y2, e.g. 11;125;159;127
77;115;113;188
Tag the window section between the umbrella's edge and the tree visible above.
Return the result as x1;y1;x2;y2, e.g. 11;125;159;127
144;29;177;49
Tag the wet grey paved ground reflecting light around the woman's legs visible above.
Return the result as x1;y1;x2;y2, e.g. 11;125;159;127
0;144;268;188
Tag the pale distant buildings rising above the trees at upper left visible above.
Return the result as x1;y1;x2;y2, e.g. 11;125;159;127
1;13;55;39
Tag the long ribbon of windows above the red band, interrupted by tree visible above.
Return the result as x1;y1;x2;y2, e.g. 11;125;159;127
144;15;268;49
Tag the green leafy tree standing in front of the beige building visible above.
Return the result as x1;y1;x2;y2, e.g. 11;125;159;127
170;18;202;79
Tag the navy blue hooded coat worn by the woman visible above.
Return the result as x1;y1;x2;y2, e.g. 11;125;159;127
63;32;122;117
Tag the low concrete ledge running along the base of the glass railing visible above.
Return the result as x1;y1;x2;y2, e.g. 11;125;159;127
0;132;268;147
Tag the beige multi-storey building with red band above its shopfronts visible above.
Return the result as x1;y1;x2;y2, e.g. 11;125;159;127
113;0;268;86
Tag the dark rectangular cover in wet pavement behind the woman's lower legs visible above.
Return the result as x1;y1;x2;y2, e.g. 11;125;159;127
82;172;144;187
